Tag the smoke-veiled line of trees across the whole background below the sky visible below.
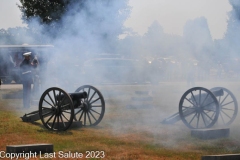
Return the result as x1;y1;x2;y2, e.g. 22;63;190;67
0;0;240;61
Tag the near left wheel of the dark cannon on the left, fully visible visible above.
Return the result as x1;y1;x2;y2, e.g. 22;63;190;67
39;87;74;131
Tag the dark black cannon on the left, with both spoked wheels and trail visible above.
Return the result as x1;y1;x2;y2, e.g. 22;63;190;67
21;85;105;131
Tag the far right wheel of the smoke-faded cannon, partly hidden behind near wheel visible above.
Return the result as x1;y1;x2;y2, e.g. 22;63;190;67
211;87;238;126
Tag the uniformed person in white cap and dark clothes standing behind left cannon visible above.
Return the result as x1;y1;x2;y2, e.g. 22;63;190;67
19;52;32;108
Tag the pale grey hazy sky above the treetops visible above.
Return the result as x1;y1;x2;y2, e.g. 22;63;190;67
0;0;232;39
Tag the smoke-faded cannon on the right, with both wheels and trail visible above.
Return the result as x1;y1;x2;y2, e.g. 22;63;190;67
162;87;238;129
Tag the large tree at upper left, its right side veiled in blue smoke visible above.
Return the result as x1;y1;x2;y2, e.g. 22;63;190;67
18;0;130;51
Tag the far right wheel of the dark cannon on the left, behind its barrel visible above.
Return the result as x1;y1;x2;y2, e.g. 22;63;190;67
74;85;105;126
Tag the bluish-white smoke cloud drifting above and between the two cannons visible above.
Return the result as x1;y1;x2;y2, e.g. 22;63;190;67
1;0;240;148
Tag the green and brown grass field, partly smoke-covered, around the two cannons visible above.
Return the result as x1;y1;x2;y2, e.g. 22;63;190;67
0;82;240;160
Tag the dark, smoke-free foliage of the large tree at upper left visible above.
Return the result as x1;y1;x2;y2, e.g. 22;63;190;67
18;0;80;37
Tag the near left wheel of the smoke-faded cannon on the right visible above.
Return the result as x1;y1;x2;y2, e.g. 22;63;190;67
179;87;219;129
